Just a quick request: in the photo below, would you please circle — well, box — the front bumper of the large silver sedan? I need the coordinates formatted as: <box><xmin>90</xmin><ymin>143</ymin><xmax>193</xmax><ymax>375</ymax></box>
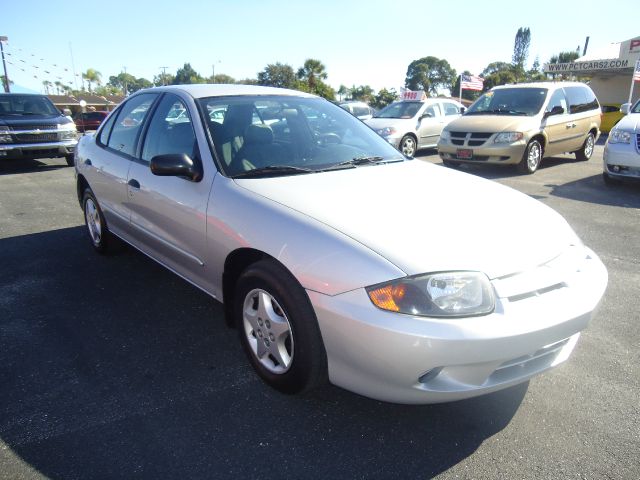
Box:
<box><xmin>308</xmin><ymin>247</ymin><xmax>607</xmax><ymax>404</ymax></box>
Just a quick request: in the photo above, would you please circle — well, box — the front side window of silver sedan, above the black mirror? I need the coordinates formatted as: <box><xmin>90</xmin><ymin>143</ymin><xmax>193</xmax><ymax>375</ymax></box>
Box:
<box><xmin>142</xmin><ymin>94</ymin><xmax>198</xmax><ymax>162</ymax></box>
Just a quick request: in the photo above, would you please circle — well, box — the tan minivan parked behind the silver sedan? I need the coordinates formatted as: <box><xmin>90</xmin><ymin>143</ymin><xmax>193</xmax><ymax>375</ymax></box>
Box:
<box><xmin>438</xmin><ymin>82</ymin><xmax>601</xmax><ymax>173</ymax></box>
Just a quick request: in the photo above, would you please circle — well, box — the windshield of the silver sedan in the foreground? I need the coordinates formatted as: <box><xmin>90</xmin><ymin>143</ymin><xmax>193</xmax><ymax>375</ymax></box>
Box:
<box><xmin>199</xmin><ymin>95</ymin><xmax>404</xmax><ymax>176</ymax></box>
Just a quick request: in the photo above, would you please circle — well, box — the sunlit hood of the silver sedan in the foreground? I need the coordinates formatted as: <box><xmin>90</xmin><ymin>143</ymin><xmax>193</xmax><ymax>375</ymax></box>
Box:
<box><xmin>236</xmin><ymin>160</ymin><xmax>580</xmax><ymax>278</ymax></box>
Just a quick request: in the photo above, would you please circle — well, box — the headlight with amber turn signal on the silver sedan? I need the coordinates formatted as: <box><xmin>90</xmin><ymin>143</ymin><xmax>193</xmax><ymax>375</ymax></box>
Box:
<box><xmin>367</xmin><ymin>272</ymin><xmax>495</xmax><ymax>317</ymax></box>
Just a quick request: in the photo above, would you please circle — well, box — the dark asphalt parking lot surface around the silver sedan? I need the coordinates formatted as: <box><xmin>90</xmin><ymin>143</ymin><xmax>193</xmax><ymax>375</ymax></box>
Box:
<box><xmin>0</xmin><ymin>142</ymin><xmax>640</xmax><ymax>479</ymax></box>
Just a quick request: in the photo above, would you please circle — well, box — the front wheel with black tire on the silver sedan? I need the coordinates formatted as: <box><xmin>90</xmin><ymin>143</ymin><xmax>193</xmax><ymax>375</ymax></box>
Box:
<box><xmin>233</xmin><ymin>259</ymin><xmax>327</xmax><ymax>394</ymax></box>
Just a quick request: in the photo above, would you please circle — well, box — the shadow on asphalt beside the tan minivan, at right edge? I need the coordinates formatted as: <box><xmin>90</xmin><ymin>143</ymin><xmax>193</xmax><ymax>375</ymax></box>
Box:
<box><xmin>545</xmin><ymin>175</ymin><xmax>640</xmax><ymax>208</ymax></box>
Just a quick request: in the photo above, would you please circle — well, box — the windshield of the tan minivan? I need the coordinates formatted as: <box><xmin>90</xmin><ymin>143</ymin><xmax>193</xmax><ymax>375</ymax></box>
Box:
<box><xmin>465</xmin><ymin>88</ymin><xmax>548</xmax><ymax>117</ymax></box>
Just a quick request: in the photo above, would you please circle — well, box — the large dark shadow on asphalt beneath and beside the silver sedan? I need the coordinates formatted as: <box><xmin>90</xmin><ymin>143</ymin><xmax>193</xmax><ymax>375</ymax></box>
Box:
<box><xmin>0</xmin><ymin>227</ymin><xmax>528</xmax><ymax>479</ymax></box>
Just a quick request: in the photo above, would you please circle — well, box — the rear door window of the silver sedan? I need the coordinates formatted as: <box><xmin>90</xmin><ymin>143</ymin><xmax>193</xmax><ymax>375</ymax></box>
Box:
<box><xmin>107</xmin><ymin>93</ymin><xmax>158</xmax><ymax>156</ymax></box>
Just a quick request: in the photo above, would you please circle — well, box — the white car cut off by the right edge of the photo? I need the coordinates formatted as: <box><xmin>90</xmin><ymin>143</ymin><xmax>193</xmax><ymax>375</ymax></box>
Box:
<box><xmin>602</xmin><ymin>101</ymin><xmax>640</xmax><ymax>184</ymax></box>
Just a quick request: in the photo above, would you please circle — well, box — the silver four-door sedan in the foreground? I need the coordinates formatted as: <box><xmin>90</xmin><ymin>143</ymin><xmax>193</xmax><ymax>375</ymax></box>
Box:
<box><xmin>76</xmin><ymin>85</ymin><xmax>607</xmax><ymax>403</ymax></box>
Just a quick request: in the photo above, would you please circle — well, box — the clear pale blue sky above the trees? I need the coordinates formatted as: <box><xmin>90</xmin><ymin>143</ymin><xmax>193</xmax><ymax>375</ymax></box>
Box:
<box><xmin>0</xmin><ymin>0</ymin><xmax>640</xmax><ymax>92</ymax></box>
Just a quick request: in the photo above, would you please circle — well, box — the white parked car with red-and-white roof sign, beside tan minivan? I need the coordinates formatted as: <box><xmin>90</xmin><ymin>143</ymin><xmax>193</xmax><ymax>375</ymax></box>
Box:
<box><xmin>366</xmin><ymin>98</ymin><xmax>464</xmax><ymax>157</ymax></box>
